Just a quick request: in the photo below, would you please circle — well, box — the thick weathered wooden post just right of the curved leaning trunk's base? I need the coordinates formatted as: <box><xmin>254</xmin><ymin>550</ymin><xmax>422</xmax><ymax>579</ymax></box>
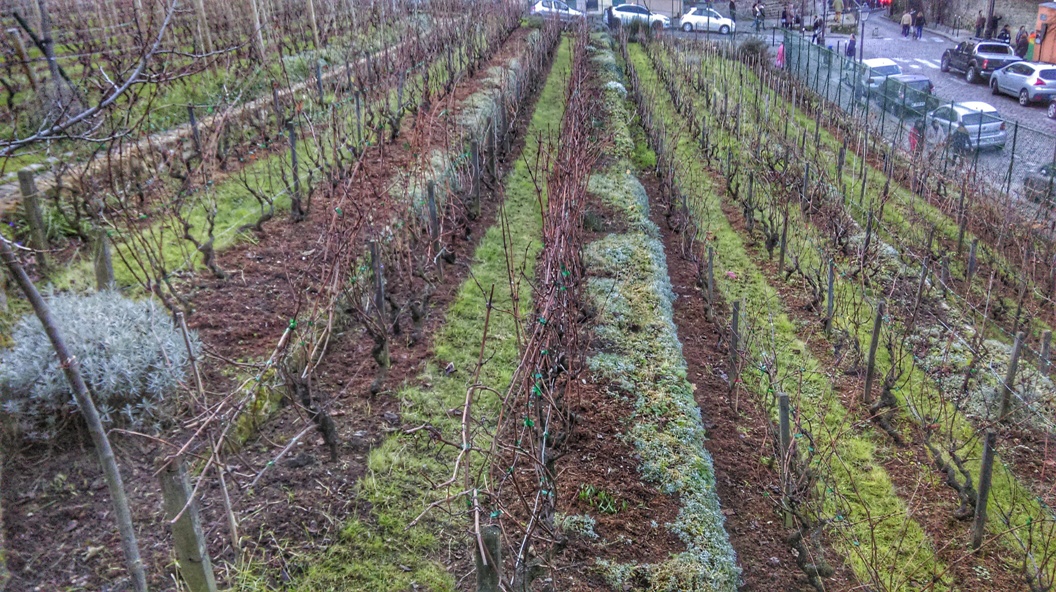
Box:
<box><xmin>158</xmin><ymin>458</ymin><xmax>216</xmax><ymax>592</ymax></box>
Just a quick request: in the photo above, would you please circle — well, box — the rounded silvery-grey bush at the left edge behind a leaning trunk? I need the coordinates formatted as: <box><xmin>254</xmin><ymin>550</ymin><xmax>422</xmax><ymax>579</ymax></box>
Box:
<box><xmin>0</xmin><ymin>291</ymin><xmax>201</xmax><ymax>439</ymax></box>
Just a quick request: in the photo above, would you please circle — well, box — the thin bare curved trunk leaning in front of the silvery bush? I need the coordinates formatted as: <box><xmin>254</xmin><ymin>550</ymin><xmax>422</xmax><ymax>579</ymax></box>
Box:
<box><xmin>0</xmin><ymin>235</ymin><xmax>147</xmax><ymax>592</ymax></box>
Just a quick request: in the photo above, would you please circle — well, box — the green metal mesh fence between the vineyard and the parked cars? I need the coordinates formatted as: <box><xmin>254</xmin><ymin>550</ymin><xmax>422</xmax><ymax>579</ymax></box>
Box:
<box><xmin>782</xmin><ymin>31</ymin><xmax>1056</xmax><ymax>200</ymax></box>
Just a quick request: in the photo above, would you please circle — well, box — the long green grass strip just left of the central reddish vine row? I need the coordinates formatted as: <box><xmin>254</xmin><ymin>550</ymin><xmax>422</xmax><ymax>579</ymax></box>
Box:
<box><xmin>266</xmin><ymin>40</ymin><xmax>571</xmax><ymax>592</ymax></box>
